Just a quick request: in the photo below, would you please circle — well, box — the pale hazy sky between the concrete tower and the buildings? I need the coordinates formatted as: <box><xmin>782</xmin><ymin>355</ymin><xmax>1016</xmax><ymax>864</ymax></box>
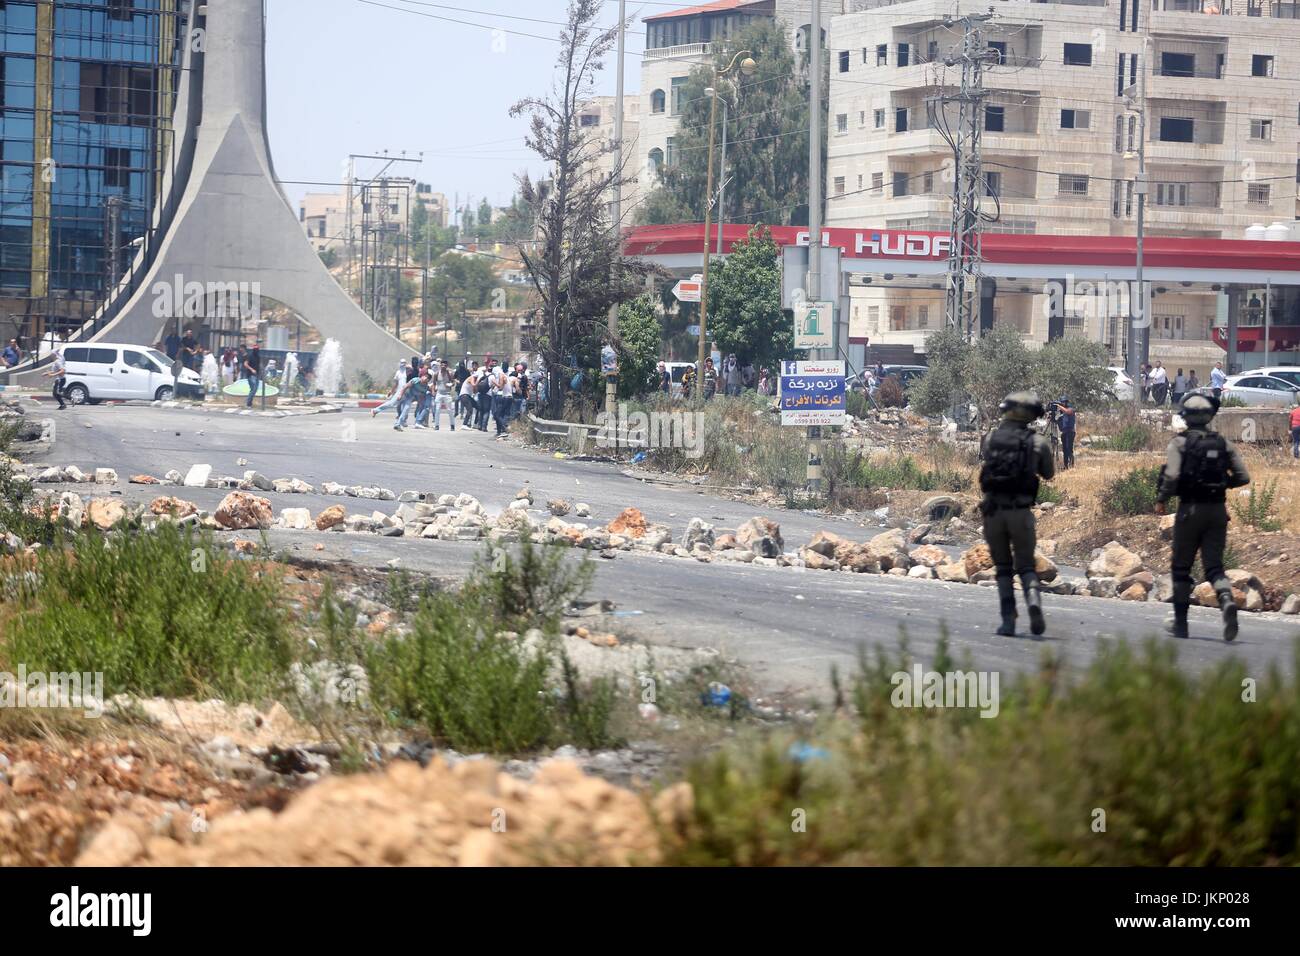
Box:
<box><xmin>267</xmin><ymin>0</ymin><xmax>650</xmax><ymax>214</ymax></box>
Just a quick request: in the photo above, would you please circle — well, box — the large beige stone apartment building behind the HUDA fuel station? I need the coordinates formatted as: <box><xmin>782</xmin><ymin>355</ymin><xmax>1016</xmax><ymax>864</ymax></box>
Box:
<box><xmin>827</xmin><ymin>0</ymin><xmax>1300</xmax><ymax>368</ymax></box>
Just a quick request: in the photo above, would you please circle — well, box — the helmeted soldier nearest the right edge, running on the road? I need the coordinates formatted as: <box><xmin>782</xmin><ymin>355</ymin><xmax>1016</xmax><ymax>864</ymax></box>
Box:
<box><xmin>1156</xmin><ymin>394</ymin><xmax>1251</xmax><ymax>641</ymax></box>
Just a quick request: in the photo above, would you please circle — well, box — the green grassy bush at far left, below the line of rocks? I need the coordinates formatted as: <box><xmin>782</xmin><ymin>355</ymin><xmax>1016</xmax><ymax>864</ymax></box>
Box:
<box><xmin>0</xmin><ymin>524</ymin><xmax>293</xmax><ymax>700</ymax></box>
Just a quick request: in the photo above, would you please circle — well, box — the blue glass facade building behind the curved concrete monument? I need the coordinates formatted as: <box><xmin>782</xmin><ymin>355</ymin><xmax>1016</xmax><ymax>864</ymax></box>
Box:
<box><xmin>0</xmin><ymin>0</ymin><xmax>189</xmax><ymax>349</ymax></box>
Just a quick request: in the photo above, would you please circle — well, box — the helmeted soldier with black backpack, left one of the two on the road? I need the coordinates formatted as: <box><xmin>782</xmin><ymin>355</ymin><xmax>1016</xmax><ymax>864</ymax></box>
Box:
<box><xmin>979</xmin><ymin>392</ymin><xmax>1056</xmax><ymax>637</ymax></box>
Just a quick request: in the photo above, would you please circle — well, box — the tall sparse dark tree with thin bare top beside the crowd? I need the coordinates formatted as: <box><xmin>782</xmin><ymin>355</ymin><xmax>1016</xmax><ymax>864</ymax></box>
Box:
<box><xmin>510</xmin><ymin>0</ymin><xmax>658</xmax><ymax>418</ymax></box>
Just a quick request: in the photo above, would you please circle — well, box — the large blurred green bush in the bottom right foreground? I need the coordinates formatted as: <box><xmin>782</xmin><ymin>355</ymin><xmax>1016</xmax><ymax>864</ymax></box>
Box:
<box><xmin>663</xmin><ymin>641</ymin><xmax>1300</xmax><ymax>866</ymax></box>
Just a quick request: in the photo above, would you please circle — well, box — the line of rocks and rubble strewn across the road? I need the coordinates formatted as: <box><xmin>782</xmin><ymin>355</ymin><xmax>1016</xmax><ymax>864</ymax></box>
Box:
<box><xmin>9</xmin><ymin>466</ymin><xmax>1300</xmax><ymax>614</ymax></box>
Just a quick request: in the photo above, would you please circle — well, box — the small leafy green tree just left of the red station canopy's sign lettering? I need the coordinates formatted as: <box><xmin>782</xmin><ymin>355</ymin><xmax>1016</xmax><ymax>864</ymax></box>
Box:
<box><xmin>706</xmin><ymin>226</ymin><xmax>794</xmax><ymax>367</ymax></box>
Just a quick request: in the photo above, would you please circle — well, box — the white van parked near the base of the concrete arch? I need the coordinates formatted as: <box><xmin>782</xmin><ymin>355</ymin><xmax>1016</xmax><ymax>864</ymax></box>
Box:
<box><xmin>64</xmin><ymin>342</ymin><xmax>203</xmax><ymax>405</ymax></box>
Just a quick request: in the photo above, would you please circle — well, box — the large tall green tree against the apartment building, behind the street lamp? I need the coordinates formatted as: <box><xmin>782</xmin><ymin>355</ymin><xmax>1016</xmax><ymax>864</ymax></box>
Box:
<box><xmin>638</xmin><ymin>20</ymin><xmax>824</xmax><ymax>225</ymax></box>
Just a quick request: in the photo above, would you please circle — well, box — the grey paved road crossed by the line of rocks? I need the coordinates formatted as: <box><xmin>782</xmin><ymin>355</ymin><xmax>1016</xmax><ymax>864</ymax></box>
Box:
<box><xmin>22</xmin><ymin>406</ymin><xmax>1300</xmax><ymax>693</ymax></box>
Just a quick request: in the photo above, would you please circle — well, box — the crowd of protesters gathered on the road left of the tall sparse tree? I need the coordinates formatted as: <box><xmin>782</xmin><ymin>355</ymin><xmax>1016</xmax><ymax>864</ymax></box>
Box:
<box><xmin>371</xmin><ymin>355</ymin><xmax>541</xmax><ymax>438</ymax></box>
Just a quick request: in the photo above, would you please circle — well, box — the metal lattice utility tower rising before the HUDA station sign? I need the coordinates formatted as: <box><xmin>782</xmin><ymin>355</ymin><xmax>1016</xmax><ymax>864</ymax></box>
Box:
<box><xmin>932</xmin><ymin>8</ymin><xmax>998</xmax><ymax>342</ymax></box>
